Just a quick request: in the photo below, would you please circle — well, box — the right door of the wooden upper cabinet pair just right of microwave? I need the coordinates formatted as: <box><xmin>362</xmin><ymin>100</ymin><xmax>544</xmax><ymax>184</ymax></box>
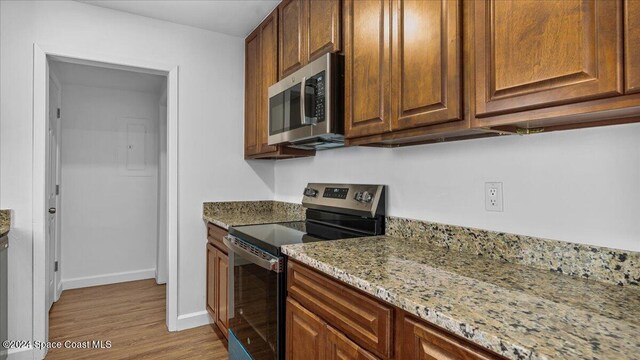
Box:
<box><xmin>391</xmin><ymin>0</ymin><xmax>462</xmax><ymax>130</ymax></box>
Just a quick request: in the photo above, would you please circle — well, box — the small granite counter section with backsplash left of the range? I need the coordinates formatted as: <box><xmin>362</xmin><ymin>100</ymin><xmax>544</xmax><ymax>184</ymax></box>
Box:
<box><xmin>202</xmin><ymin>200</ymin><xmax>305</xmax><ymax>229</ymax></box>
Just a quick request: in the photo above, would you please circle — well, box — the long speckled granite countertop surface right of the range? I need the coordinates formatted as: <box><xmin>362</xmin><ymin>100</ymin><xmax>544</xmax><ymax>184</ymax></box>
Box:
<box><xmin>283</xmin><ymin>236</ymin><xmax>640</xmax><ymax>359</ymax></box>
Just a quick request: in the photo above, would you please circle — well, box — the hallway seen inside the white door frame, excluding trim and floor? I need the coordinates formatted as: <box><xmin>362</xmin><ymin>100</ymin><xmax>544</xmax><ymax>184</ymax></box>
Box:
<box><xmin>45</xmin><ymin>59</ymin><xmax>167</xmax><ymax>336</ymax></box>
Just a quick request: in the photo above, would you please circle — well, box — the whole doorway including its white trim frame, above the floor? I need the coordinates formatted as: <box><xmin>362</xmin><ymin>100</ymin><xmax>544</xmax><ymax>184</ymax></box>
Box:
<box><xmin>33</xmin><ymin>44</ymin><xmax>178</xmax><ymax>357</ymax></box>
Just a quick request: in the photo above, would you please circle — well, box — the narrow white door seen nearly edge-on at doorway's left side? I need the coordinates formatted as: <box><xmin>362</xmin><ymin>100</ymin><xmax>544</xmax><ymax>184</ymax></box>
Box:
<box><xmin>45</xmin><ymin>71</ymin><xmax>60</xmax><ymax>310</ymax></box>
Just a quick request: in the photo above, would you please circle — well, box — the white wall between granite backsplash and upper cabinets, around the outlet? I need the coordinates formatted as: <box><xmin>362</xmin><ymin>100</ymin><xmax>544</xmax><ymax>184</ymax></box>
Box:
<box><xmin>275</xmin><ymin>124</ymin><xmax>640</xmax><ymax>251</ymax></box>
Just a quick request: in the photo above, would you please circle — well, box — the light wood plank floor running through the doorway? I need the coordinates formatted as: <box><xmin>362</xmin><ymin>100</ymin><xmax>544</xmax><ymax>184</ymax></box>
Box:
<box><xmin>46</xmin><ymin>280</ymin><xmax>227</xmax><ymax>360</ymax></box>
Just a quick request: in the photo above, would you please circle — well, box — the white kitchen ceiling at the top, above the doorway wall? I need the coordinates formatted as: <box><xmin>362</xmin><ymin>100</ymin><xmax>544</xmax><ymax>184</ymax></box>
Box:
<box><xmin>76</xmin><ymin>0</ymin><xmax>279</xmax><ymax>37</ymax></box>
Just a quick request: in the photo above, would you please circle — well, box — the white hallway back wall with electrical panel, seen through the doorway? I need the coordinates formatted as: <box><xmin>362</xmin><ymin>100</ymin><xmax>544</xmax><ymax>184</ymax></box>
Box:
<box><xmin>60</xmin><ymin>80</ymin><xmax>160</xmax><ymax>289</ymax></box>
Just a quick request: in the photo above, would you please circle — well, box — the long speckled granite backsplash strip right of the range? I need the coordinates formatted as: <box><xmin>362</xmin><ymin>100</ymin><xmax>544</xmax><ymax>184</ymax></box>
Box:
<box><xmin>385</xmin><ymin>217</ymin><xmax>640</xmax><ymax>286</ymax></box>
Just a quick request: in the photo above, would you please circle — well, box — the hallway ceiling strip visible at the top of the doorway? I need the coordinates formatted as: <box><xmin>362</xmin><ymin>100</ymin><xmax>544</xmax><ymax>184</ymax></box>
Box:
<box><xmin>49</xmin><ymin>61</ymin><xmax>166</xmax><ymax>94</ymax></box>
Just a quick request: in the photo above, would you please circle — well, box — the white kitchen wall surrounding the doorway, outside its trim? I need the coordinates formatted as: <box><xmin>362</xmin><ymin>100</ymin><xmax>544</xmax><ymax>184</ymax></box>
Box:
<box><xmin>0</xmin><ymin>1</ymin><xmax>274</xmax><ymax>348</ymax></box>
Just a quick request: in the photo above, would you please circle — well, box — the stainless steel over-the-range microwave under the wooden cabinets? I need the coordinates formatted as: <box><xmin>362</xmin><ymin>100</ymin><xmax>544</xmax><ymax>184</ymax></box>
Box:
<box><xmin>269</xmin><ymin>54</ymin><xmax>344</xmax><ymax>150</ymax></box>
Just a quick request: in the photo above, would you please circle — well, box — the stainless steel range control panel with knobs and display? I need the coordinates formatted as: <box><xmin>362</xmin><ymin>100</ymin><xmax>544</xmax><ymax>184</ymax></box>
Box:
<box><xmin>302</xmin><ymin>183</ymin><xmax>385</xmax><ymax>217</ymax></box>
